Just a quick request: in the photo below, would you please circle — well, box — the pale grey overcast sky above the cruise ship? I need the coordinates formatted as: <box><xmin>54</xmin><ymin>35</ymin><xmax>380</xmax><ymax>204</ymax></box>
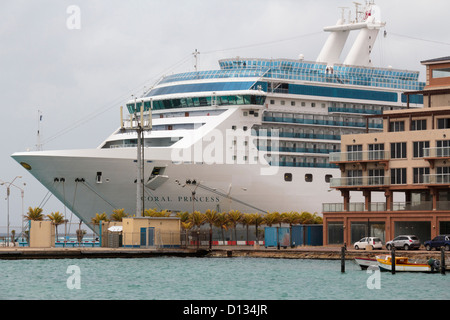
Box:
<box><xmin>0</xmin><ymin>0</ymin><xmax>450</xmax><ymax>232</ymax></box>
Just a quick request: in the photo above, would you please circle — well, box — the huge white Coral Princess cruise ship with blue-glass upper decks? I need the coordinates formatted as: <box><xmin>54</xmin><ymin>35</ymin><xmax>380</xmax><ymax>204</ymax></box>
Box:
<box><xmin>12</xmin><ymin>1</ymin><xmax>424</xmax><ymax>229</ymax></box>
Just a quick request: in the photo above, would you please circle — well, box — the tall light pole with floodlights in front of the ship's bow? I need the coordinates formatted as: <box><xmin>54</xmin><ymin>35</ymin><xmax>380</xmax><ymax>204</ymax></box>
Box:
<box><xmin>120</xmin><ymin>98</ymin><xmax>153</xmax><ymax>217</ymax></box>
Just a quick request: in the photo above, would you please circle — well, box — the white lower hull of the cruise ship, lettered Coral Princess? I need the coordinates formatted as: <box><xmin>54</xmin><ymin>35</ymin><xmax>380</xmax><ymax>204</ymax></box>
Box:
<box><xmin>13</xmin><ymin>148</ymin><xmax>339</xmax><ymax>224</ymax></box>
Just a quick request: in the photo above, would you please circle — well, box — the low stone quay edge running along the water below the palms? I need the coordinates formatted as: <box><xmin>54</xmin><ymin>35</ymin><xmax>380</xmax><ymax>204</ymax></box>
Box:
<box><xmin>0</xmin><ymin>246</ymin><xmax>444</xmax><ymax>265</ymax></box>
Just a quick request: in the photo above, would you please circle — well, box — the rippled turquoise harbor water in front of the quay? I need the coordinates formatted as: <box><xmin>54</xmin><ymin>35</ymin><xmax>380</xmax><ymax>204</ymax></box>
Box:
<box><xmin>0</xmin><ymin>257</ymin><xmax>450</xmax><ymax>300</ymax></box>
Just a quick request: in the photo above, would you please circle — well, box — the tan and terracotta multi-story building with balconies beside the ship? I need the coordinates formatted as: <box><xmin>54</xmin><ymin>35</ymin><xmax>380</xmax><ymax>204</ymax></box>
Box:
<box><xmin>323</xmin><ymin>57</ymin><xmax>450</xmax><ymax>244</ymax></box>
